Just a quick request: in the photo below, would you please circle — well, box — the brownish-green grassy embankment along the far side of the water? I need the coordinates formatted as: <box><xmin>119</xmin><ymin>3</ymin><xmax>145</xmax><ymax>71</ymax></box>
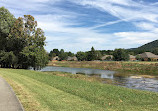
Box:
<box><xmin>48</xmin><ymin>61</ymin><xmax>158</xmax><ymax>75</ymax></box>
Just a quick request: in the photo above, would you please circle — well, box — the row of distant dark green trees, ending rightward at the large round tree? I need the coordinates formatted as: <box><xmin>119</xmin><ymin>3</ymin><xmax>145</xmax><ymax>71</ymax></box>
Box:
<box><xmin>49</xmin><ymin>47</ymin><xmax>129</xmax><ymax>61</ymax></box>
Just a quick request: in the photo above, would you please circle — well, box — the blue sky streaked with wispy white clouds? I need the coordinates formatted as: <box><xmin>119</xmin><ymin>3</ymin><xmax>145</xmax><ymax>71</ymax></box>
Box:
<box><xmin>0</xmin><ymin>0</ymin><xmax>158</xmax><ymax>52</ymax></box>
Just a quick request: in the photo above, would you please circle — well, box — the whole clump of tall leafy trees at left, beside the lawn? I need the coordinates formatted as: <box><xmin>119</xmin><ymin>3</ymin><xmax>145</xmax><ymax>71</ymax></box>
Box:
<box><xmin>0</xmin><ymin>7</ymin><xmax>48</xmax><ymax>69</ymax></box>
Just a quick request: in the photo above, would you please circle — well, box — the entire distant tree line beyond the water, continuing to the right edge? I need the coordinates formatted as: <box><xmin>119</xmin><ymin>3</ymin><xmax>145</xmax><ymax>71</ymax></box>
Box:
<box><xmin>49</xmin><ymin>44</ymin><xmax>158</xmax><ymax>61</ymax></box>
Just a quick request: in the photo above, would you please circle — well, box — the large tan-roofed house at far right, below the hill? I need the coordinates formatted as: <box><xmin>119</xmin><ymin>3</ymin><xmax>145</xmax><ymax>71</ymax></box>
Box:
<box><xmin>139</xmin><ymin>52</ymin><xmax>158</xmax><ymax>61</ymax></box>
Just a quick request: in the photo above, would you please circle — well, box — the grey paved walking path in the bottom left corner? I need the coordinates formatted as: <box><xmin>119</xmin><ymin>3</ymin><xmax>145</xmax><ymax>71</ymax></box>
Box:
<box><xmin>0</xmin><ymin>77</ymin><xmax>24</xmax><ymax>111</ymax></box>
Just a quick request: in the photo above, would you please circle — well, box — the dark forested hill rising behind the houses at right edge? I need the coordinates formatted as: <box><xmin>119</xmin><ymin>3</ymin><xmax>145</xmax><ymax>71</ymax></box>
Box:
<box><xmin>137</xmin><ymin>40</ymin><xmax>158</xmax><ymax>51</ymax></box>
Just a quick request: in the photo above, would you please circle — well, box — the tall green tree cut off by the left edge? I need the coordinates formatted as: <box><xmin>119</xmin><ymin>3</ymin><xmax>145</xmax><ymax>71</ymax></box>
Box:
<box><xmin>0</xmin><ymin>7</ymin><xmax>16</xmax><ymax>67</ymax></box>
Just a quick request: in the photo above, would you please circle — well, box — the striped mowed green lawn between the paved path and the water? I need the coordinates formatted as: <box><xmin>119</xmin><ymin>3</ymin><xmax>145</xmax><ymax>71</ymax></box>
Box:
<box><xmin>0</xmin><ymin>69</ymin><xmax>158</xmax><ymax>111</ymax></box>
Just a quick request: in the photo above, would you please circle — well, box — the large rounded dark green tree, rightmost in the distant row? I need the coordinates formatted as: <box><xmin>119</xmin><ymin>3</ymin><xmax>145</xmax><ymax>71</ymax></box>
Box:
<box><xmin>113</xmin><ymin>49</ymin><xmax>129</xmax><ymax>61</ymax></box>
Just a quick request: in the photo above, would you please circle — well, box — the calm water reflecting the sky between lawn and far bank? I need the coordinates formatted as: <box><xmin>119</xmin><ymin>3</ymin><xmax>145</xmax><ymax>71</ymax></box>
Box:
<box><xmin>41</xmin><ymin>66</ymin><xmax>158</xmax><ymax>92</ymax></box>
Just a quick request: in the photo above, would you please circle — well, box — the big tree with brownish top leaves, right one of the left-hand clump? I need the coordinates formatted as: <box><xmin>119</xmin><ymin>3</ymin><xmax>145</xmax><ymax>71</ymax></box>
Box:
<box><xmin>8</xmin><ymin>15</ymin><xmax>48</xmax><ymax>69</ymax></box>
